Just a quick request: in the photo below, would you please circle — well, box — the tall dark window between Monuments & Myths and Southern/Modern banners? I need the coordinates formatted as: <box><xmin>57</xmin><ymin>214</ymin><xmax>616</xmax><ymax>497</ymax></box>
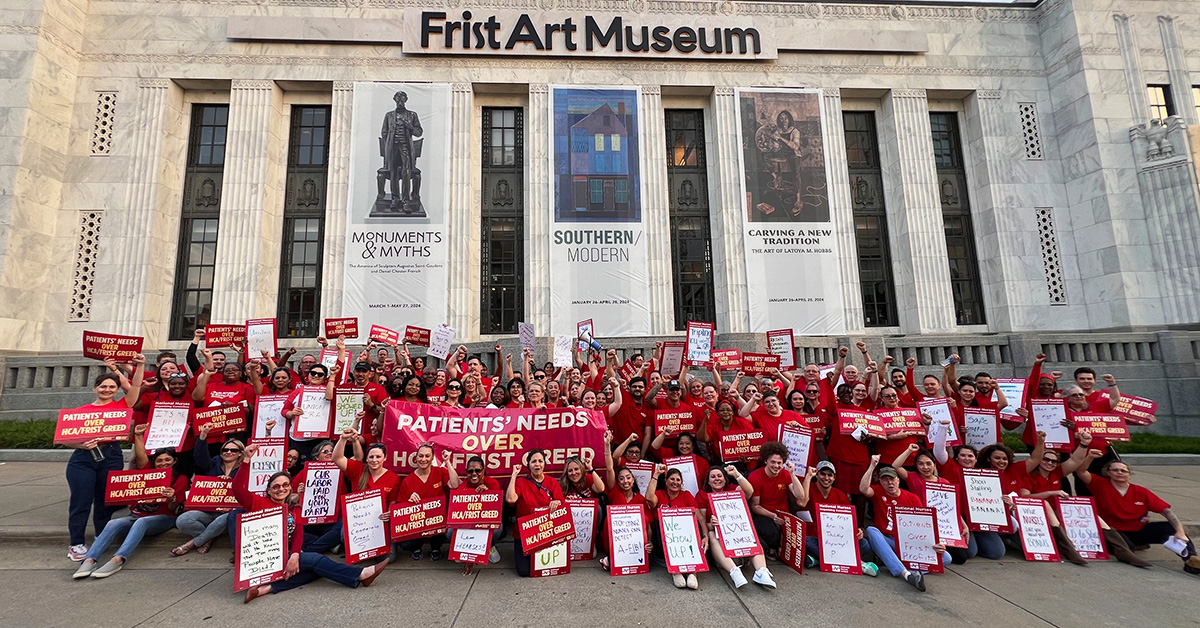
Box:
<box><xmin>479</xmin><ymin>107</ymin><xmax>523</xmax><ymax>334</ymax></box>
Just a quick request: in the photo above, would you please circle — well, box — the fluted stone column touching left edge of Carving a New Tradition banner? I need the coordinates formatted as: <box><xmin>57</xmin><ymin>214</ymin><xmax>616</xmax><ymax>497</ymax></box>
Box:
<box><xmin>706</xmin><ymin>88</ymin><xmax>750</xmax><ymax>334</ymax></box>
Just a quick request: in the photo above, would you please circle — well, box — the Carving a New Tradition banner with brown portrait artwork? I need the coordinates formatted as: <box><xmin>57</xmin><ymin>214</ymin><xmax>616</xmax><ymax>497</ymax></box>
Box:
<box><xmin>737</xmin><ymin>89</ymin><xmax>845</xmax><ymax>336</ymax></box>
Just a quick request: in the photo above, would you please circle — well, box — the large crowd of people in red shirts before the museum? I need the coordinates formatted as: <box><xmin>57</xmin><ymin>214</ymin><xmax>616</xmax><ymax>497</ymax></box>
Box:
<box><xmin>66</xmin><ymin>330</ymin><xmax>1200</xmax><ymax>602</ymax></box>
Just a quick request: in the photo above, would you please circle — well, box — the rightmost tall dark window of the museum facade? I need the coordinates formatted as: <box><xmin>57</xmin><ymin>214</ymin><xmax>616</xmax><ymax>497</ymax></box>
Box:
<box><xmin>929</xmin><ymin>113</ymin><xmax>986</xmax><ymax>325</ymax></box>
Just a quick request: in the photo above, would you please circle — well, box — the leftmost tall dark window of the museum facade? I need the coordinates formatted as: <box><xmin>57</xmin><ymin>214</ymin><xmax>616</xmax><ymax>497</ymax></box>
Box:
<box><xmin>170</xmin><ymin>104</ymin><xmax>229</xmax><ymax>340</ymax></box>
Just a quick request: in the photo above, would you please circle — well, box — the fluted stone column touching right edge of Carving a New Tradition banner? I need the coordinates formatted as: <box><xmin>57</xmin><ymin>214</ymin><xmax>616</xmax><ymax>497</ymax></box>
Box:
<box><xmin>824</xmin><ymin>88</ymin><xmax>863</xmax><ymax>334</ymax></box>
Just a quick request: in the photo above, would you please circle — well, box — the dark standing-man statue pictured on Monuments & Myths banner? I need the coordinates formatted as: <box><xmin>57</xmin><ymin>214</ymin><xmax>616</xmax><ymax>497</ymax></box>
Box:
<box><xmin>371</xmin><ymin>91</ymin><xmax>426</xmax><ymax>217</ymax></box>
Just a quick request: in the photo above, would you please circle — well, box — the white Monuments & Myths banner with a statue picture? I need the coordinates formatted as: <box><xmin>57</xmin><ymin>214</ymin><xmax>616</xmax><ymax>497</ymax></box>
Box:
<box><xmin>345</xmin><ymin>83</ymin><xmax>450</xmax><ymax>329</ymax></box>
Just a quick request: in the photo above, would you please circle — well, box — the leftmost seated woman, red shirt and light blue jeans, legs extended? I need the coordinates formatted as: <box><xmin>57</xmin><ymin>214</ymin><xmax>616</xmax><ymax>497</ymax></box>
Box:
<box><xmin>72</xmin><ymin>446</ymin><xmax>188</xmax><ymax>580</ymax></box>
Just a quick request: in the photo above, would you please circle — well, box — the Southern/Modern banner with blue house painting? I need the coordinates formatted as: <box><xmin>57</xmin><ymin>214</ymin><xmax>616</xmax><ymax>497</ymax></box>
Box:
<box><xmin>548</xmin><ymin>85</ymin><xmax>650</xmax><ymax>336</ymax></box>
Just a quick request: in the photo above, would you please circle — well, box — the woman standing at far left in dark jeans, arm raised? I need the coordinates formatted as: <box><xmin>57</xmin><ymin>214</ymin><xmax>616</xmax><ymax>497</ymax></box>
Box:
<box><xmin>66</xmin><ymin>353</ymin><xmax>146</xmax><ymax>562</ymax></box>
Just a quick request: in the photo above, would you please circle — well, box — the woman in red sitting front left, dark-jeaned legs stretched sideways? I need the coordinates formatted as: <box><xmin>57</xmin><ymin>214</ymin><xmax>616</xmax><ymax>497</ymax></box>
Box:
<box><xmin>233</xmin><ymin>441</ymin><xmax>388</xmax><ymax>604</ymax></box>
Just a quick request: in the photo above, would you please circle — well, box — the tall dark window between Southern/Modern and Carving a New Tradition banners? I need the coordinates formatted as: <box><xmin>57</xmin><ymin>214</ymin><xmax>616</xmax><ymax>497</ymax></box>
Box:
<box><xmin>667</xmin><ymin>109</ymin><xmax>716</xmax><ymax>331</ymax></box>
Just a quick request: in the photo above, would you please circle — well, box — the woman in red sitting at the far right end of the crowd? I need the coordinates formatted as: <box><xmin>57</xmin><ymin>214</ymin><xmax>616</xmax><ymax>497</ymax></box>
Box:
<box><xmin>1075</xmin><ymin>432</ymin><xmax>1200</xmax><ymax>575</ymax></box>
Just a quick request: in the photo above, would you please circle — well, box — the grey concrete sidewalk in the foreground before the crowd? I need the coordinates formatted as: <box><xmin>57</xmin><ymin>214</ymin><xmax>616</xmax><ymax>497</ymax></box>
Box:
<box><xmin>0</xmin><ymin>462</ymin><xmax>1200</xmax><ymax>628</ymax></box>
